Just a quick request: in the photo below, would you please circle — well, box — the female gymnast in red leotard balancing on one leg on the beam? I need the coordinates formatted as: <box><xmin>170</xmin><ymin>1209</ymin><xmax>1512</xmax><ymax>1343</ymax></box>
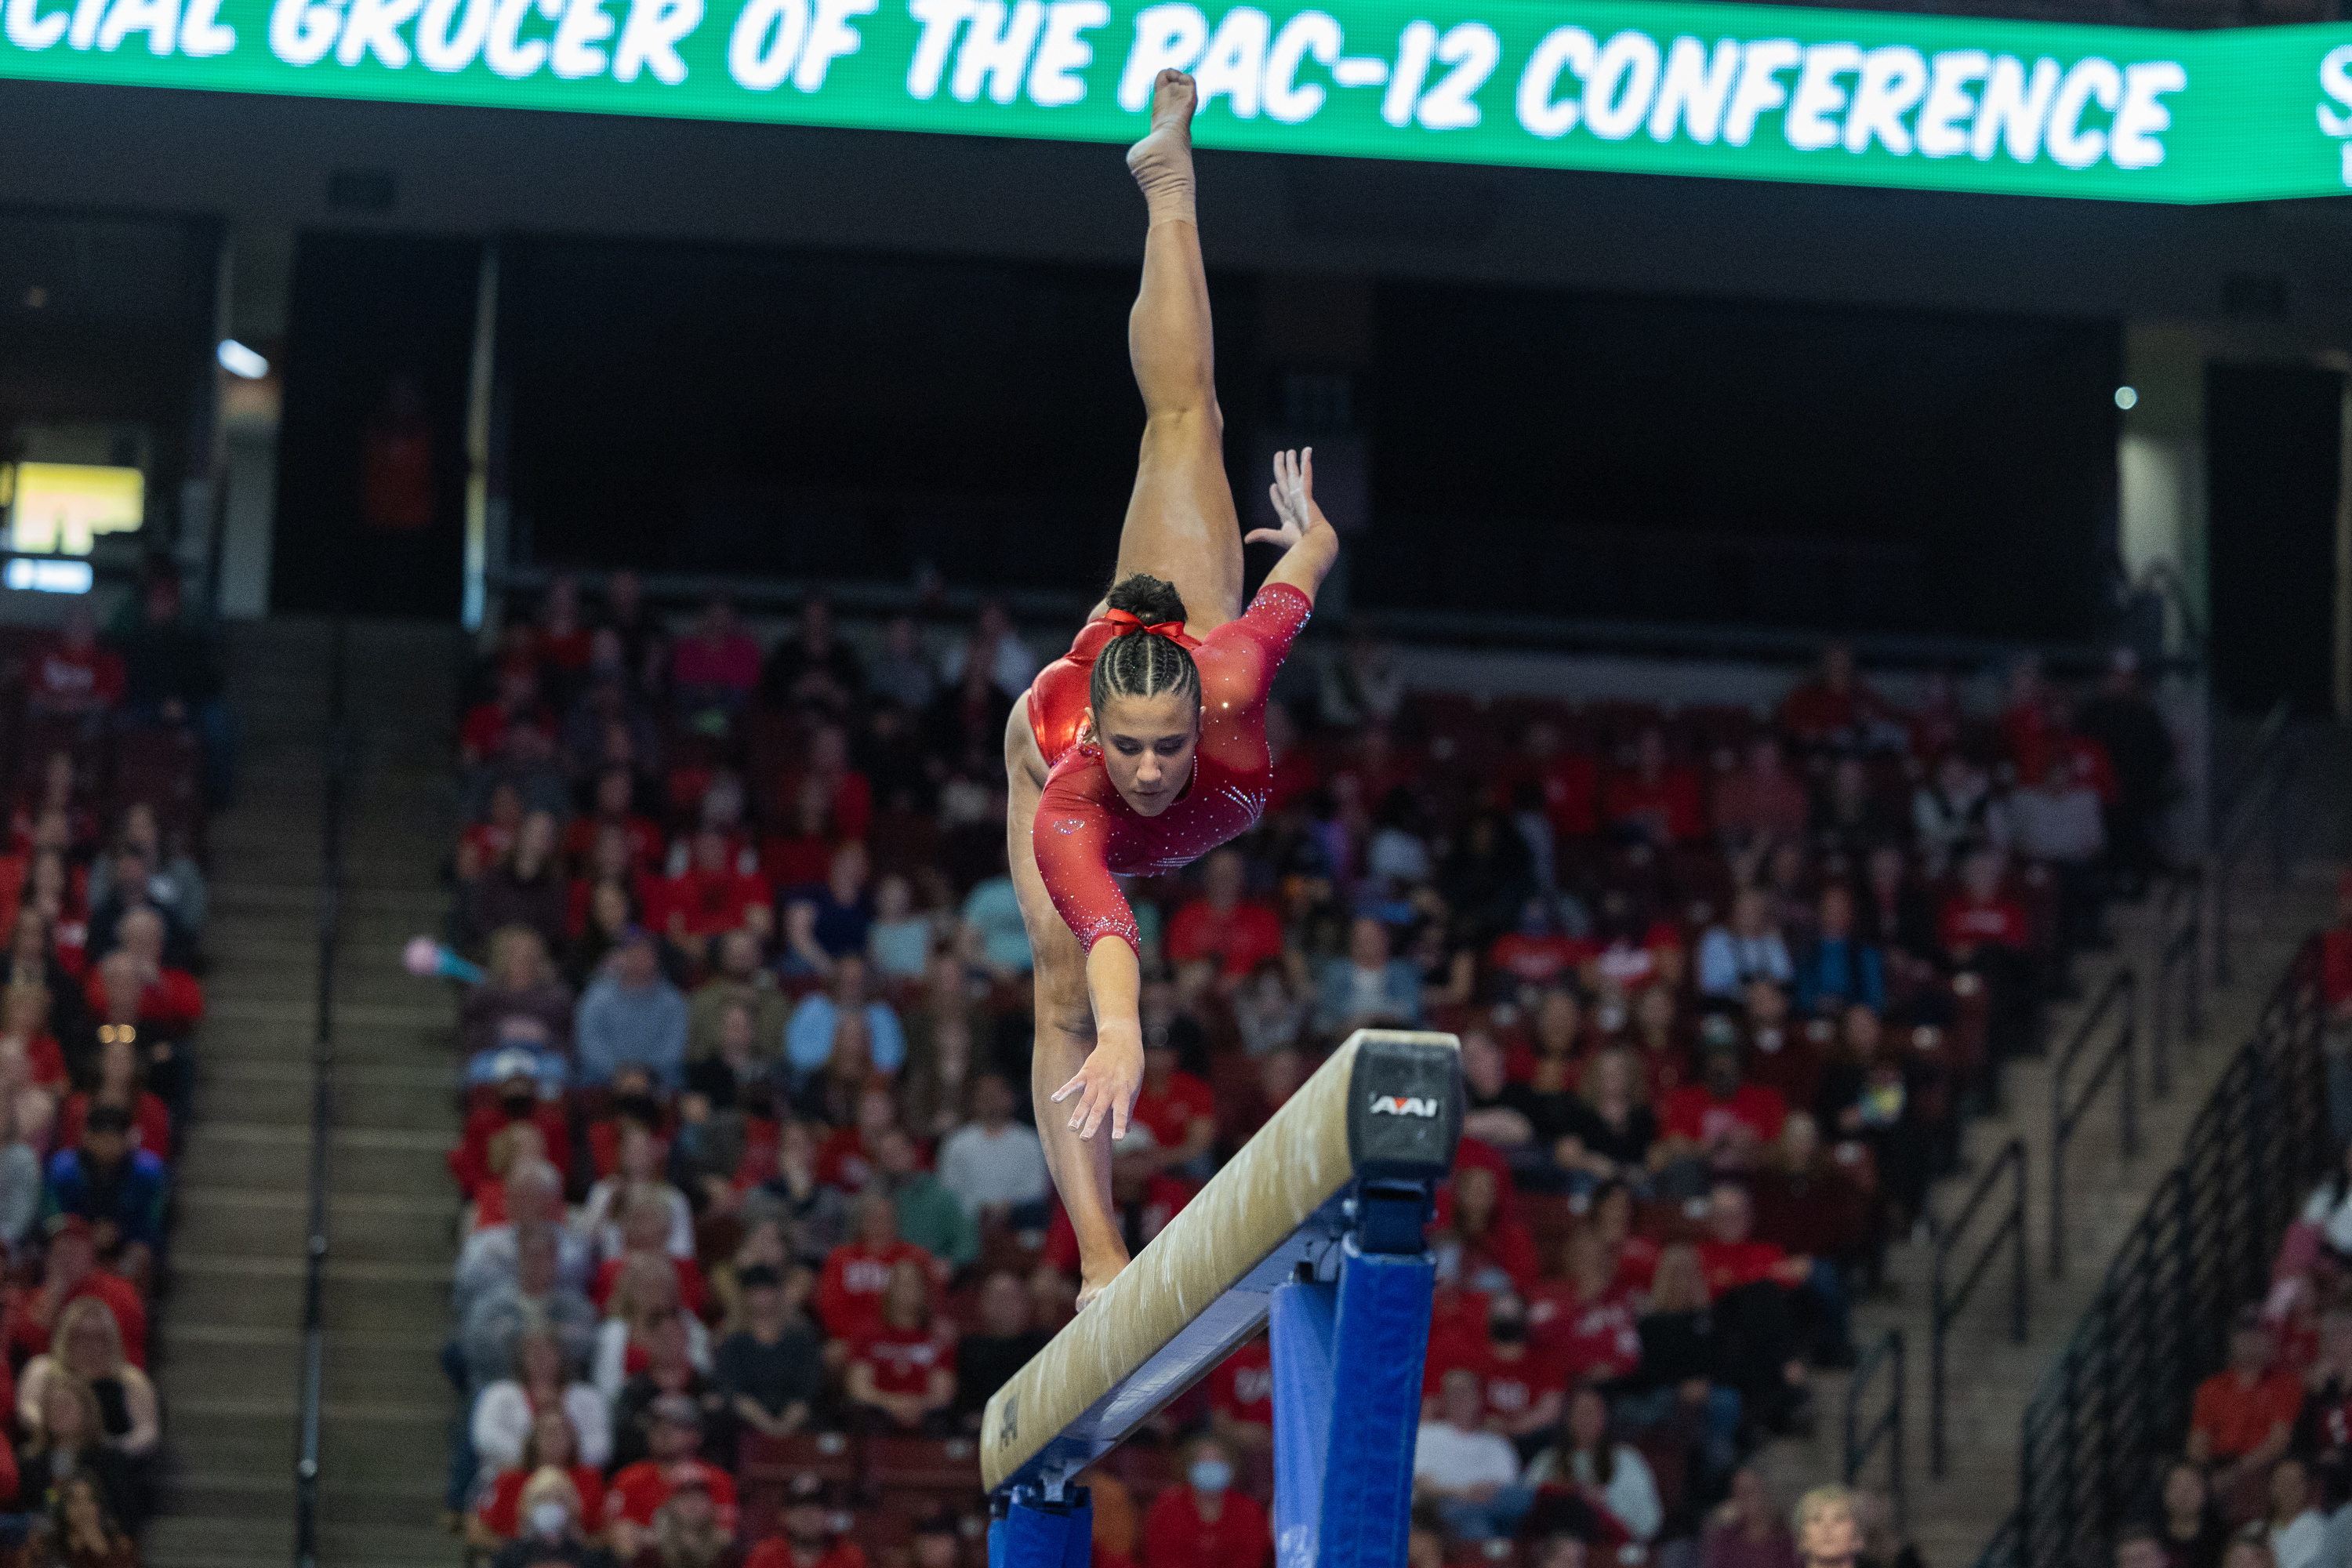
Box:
<box><xmin>1004</xmin><ymin>71</ymin><xmax>1338</xmax><ymax>1305</ymax></box>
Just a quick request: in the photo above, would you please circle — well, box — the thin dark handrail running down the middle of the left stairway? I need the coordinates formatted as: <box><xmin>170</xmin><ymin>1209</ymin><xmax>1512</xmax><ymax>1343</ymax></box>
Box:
<box><xmin>294</xmin><ymin>614</ymin><xmax>350</xmax><ymax>1568</ymax></box>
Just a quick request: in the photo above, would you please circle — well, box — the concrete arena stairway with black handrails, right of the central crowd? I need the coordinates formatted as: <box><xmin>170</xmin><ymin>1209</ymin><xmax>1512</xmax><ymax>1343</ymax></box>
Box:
<box><xmin>1759</xmin><ymin>860</ymin><xmax>2343</xmax><ymax>1568</ymax></box>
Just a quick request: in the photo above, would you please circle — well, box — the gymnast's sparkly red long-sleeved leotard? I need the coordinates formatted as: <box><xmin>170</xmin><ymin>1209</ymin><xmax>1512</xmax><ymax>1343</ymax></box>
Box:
<box><xmin>1028</xmin><ymin>583</ymin><xmax>1312</xmax><ymax>952</ymax></box>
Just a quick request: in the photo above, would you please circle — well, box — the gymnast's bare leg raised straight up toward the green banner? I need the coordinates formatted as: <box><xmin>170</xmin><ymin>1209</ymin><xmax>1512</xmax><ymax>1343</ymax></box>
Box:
<box><xmin>1117</xmin><ymin>71</ymin><xmax>1242</xmax><ymax>637</ymax></box>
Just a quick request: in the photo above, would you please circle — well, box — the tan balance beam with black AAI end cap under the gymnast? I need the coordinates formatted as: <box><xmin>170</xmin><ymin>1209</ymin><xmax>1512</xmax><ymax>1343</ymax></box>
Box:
<box><xmin>981</xmin><ymin>1029</ymin><xmax>1463</xmax><ymax>1504</ymax></box>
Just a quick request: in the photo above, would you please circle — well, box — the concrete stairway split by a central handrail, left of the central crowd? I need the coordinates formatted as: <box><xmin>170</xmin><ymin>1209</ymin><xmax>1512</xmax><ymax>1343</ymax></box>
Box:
<box><xmin>148</xmin><ymin>621</ymin><xmax>463</xmax><ymax>1568</ymax></box>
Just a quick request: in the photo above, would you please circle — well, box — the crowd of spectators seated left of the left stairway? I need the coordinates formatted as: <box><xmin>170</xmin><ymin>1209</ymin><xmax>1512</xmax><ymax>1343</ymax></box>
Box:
<box><xmin>0</xmin><ymin>562</ymin><xmax>233</xmax><ymax>1568</ymax></box>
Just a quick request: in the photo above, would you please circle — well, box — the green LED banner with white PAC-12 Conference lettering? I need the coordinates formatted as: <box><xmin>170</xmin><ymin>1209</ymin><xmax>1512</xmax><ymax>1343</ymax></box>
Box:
<box><xmin>13</xmin><ymin>0</ymin><xmax>2352</xmax><ymax>202</ymax></box>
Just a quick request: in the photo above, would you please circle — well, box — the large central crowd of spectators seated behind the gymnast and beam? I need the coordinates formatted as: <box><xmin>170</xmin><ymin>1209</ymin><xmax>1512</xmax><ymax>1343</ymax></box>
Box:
<box><xmin>445</xmin><ymin>574</ymin><xmax>2171</xmax><ymax>1568</ymax></box>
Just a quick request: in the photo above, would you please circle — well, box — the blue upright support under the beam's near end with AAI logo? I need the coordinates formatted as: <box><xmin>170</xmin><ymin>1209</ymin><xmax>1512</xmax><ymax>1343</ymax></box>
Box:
<box><xmin>1279</xmin><ymin>1236</ymin><xmax>1437</xmax><ymax>1568</ymax></box>
